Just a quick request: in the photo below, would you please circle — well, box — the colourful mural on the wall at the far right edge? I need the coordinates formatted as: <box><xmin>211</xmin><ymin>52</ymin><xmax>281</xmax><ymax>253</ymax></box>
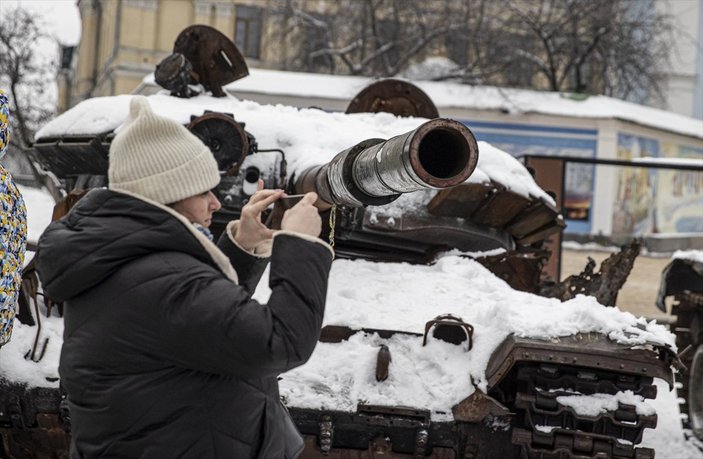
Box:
<box><xmin>612</xmin><ymin>133</ymin><xmax>703</xmax><ymax>235</ymax></box>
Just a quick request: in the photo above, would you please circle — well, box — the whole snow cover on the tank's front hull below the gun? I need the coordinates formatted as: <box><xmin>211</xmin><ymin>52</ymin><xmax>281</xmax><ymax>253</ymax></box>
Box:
<box><xmin>255</xmin><ymin>254</ymin><xmax>676</xmax><ymax>419</ymax></box>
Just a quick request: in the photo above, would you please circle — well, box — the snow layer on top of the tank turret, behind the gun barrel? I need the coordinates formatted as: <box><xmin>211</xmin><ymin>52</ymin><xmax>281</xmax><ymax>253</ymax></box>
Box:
<box><xmin>36</xmin><ymin>94</ymin><xmax>554</xmax><ymax>204</ymax></box>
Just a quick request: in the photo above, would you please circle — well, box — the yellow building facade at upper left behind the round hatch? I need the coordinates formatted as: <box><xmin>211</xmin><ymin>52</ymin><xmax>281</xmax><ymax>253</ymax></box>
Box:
<box><xmin>59</xmin><ymin>0</ymin><xmax>278</xmax><ymax>112</ymax></box>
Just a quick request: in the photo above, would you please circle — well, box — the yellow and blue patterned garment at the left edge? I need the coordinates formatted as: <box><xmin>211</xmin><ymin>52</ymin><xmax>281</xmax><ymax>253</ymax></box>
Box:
<box><xmin>0</xmin><ymin>90</ymin><xmax>27</xmax><ymax>346</ymax></box>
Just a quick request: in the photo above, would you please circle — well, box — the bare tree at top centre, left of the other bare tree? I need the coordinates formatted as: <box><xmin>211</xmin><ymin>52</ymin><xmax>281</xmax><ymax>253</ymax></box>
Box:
<box><xmin>275</xmin><ymin>0</ymin><xmax>483</xmax><ymax>77</ymax></box>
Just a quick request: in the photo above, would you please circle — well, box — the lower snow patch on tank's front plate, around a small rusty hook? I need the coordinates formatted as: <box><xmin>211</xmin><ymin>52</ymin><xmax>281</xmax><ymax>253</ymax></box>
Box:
<box><xmin>279</xmin><ymin>333</ymin><xmax>476</xmax><ymax>421</ymax></box>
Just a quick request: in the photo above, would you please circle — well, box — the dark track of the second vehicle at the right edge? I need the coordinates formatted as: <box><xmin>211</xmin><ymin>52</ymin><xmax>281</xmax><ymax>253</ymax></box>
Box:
<box><xmin>671</xmin><ymin>292</ymin><xmax>703</xmax><ymax>437</ymax></box>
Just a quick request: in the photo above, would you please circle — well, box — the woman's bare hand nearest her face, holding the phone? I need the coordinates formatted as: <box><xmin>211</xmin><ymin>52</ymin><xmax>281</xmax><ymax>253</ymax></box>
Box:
<box><xmin>234</xmin><ymin>180</ymin><xmax>284</xmax><ymax>251</ymax></box>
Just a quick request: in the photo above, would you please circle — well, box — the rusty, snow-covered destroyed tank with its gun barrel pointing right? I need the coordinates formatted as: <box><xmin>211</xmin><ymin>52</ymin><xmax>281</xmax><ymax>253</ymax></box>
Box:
<box><xmin>0</xmin><ymin>26</ymin><xmax>676</xmax><ymax>459</ymax></box>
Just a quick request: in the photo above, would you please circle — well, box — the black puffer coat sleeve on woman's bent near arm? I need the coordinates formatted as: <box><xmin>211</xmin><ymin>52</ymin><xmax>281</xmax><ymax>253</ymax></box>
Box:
<box><xmin>155</xmin><ymin>235</ymin><xmax>332</xmax><ymax>378</ymax></box>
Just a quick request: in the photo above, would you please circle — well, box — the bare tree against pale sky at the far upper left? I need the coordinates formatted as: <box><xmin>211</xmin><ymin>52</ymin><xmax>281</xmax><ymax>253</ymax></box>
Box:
<box><xmin>0</xmin><ymin>8</ymin><xmax>56</xmax><ymax>150</ymax></box>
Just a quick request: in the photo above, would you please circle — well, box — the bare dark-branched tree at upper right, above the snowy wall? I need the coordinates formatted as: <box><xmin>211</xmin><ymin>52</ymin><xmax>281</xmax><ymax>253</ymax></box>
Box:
<box><xmin>498</xmin><ymin>0</ymin><xmax>670</xmax><ymax>98</ymax></box>
